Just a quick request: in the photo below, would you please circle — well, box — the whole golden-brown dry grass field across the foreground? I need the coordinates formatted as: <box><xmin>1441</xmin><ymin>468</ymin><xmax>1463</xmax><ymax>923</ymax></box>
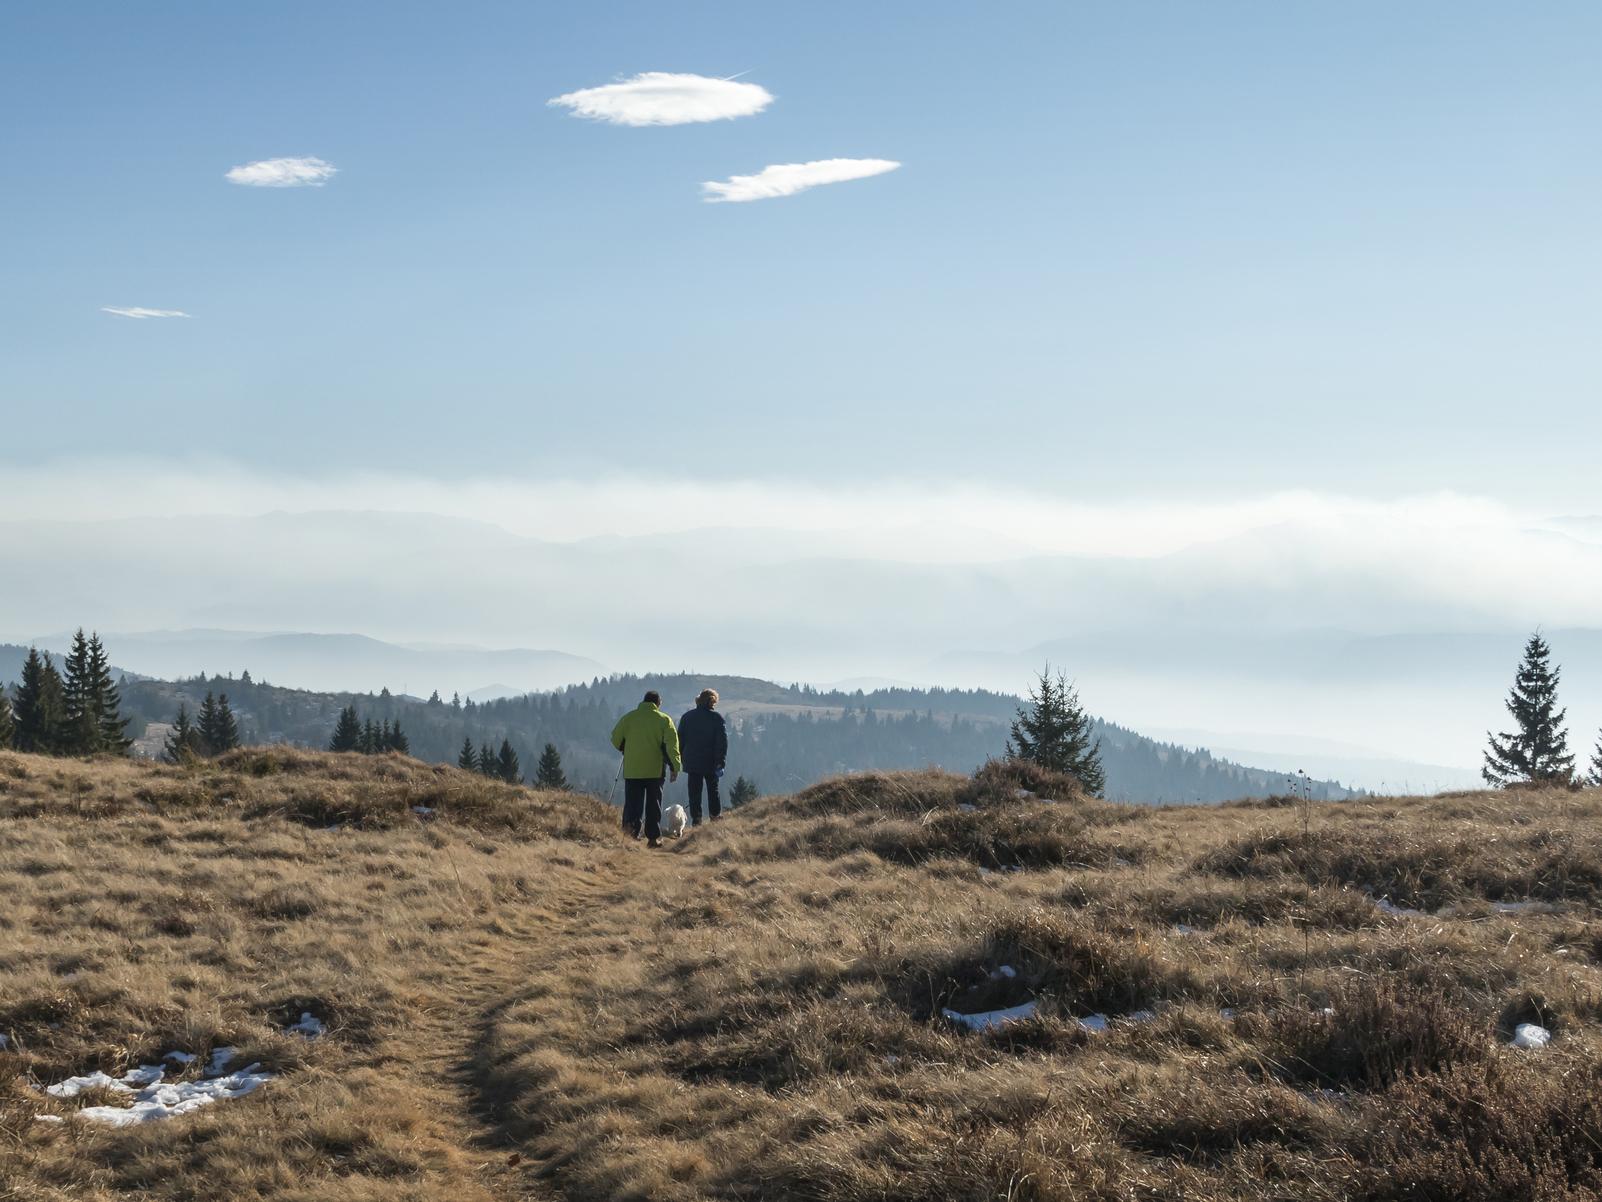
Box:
<box><xmin>0</xmin><ymin>750</ymin><xmax>1602</xmax><ymax>1202</ymax></box>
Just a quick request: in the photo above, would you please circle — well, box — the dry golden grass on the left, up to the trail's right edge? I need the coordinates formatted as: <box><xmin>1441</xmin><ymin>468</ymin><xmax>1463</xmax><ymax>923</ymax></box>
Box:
<box><xmin>0</xmin><ymin>752</ymin><xmax>612</xmax><ymax>1202</ymax></box>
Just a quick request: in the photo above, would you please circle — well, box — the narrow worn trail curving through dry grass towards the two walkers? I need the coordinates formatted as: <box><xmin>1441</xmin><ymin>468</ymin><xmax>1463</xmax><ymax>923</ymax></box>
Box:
<box><xmin>381</xmin><ymin>848</ymin><xmax>642</xmax><ymax>1202</ymax></box>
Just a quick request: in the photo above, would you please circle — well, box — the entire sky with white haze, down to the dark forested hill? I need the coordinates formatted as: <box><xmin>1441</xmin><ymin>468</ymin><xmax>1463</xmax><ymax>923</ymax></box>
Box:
<box><xmin>0</xmin><ymin>0</ymin><xmax>1602</xmax><ymax>785</ymax></box>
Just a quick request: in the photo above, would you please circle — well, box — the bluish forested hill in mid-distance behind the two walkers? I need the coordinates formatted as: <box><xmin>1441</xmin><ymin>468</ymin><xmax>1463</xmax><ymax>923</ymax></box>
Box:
<box><xmin>0</xmin><ymin>646</ymin><xmax>1350</xmax><ymax>803</ymax></box>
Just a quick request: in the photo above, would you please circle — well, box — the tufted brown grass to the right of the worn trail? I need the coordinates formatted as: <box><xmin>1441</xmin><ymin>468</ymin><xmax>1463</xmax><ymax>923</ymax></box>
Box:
<box><xmin>487</xmin><ymin>774</ymin><xmax>1602</xmax><ymax>1202</ymax></box>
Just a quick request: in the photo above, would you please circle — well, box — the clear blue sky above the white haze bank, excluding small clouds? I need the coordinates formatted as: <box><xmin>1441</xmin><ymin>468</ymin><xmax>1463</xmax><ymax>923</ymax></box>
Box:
<box><xmin>0</xmin><ymin>0</ymin><xmax>1602</xmax><ymax>500</ymax></box>
